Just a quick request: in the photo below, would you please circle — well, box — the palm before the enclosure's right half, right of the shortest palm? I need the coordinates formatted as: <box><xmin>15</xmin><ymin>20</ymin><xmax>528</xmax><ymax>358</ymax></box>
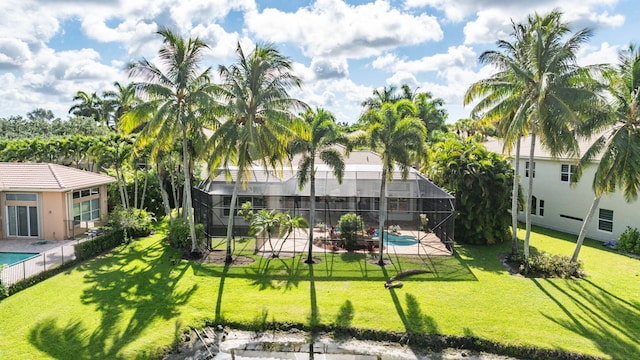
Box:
<box><xmin>359</xmin><ymin>99</ymin><xmax>427</xmax><ymax>265</ymax></box>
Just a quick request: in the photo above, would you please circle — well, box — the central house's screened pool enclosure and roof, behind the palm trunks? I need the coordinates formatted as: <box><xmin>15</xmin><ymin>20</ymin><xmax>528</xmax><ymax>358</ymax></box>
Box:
<box><xmin>193</xmin><ymin>151</ymin><xmax>455</xmax><ymax>254</ymax></box>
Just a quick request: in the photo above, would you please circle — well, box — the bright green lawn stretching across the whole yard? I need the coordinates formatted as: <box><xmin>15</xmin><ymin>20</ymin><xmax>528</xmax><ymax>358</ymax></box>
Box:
<box><xmin>0</xmin><ymin>225</ymin><xmax>640</xmax><ymax>359</ymax></box>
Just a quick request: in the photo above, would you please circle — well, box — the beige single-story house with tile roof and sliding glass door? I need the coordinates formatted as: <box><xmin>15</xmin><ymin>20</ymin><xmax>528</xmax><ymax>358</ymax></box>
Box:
<box><xmin>0</xmin><ymin>162</ymin><xmax>116</xmax><ymax>240</ymax></box>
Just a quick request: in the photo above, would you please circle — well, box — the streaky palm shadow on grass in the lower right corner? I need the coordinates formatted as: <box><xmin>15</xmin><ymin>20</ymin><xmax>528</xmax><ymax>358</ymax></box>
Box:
<box><xmin>532</xmin><ymin>279</ymin><xmax>640</xmax><ymax>359</ymax></box>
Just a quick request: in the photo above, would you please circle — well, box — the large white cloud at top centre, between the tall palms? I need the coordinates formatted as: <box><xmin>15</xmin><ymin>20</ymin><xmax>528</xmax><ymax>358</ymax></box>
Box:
<box><xmin>242</xmin><ymin>0</ymin><xmax>443</xmax><ymax>59</ymax></box>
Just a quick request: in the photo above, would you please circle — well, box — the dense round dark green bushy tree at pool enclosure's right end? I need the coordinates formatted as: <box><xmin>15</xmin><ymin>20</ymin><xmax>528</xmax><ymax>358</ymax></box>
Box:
<box><xmin>428</xmin><ymin>138</ymin><xmax>513</xmax><ymax>245</ymax></box>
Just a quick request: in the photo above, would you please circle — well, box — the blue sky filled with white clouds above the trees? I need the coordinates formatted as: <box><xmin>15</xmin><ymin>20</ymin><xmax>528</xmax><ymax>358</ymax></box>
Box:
<box><xmin>0</xmin><ymin>0</ymin><xmax>640</xmax><ymax>123</ymax></box>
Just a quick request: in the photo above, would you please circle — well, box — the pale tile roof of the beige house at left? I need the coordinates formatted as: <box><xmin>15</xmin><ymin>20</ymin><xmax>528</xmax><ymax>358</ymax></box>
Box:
<box><xmin>0</xmin><ymin>162</ymin><xmax>116</xmax><ymax>191</ymax></box>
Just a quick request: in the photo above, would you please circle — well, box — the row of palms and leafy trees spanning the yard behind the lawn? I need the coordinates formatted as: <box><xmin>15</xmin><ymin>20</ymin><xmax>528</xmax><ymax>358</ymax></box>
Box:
<box><xmin>2</xmin><ymin>11</ymin><xmax>640</xmax><ymax>270</ymax></box>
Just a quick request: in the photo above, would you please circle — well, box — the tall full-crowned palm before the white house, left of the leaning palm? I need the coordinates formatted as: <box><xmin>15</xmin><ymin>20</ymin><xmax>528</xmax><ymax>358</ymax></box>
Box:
<box><xmin>465</xmin><ymin>10</ymin><xmax>600</xmax><ymax>264</ymax></box>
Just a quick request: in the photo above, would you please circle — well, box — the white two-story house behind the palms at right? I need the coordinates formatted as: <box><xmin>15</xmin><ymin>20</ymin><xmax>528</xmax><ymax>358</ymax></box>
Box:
<box><xmin>485</xmin><ymin>136</ymin><xmax>640</xmax><ymax>241</ymax></box>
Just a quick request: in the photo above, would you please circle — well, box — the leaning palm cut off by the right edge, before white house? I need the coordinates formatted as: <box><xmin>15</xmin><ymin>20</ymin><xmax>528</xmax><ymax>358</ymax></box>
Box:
<box><xmin>571</xmin><ymin>44</ymin><xmax>640</xmax><ymax>262</ymax></box>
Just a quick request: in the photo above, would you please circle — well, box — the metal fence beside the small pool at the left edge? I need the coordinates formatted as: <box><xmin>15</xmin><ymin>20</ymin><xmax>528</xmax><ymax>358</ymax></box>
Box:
<box><xmin>0</xmin><ymin>240</ymin><xmax>80</xmax><ymax>286</ymax></box>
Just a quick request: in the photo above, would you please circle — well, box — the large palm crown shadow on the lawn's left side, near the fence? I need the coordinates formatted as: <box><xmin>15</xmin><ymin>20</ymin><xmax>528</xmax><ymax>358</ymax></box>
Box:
<box><xmin>29</xmin><ymin>241</ymin><xmax>197</xmax><ymax>359</ymax></box>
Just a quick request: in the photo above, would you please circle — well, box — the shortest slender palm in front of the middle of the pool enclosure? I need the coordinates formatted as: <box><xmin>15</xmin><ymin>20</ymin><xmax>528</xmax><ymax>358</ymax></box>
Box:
<box><xmin>290</xmin><ymin>109</ymin><xmax>347</xmax><ymax>264</ymax></box>
